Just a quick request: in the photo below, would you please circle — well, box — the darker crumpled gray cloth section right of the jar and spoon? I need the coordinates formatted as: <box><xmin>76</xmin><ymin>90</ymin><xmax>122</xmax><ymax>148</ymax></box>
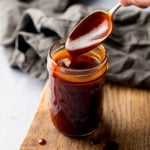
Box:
<box><xmin>104</xmin><ymin>10</ymin><xmax>150</xmax><ymax>88</ymax></box>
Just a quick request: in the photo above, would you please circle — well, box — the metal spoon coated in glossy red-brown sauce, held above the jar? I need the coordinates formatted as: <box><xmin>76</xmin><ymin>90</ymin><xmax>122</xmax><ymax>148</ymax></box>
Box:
<box><xmin>65</xmin><ymin>3</ymin><xmax>121</xmax><ymax>55</ymax></box>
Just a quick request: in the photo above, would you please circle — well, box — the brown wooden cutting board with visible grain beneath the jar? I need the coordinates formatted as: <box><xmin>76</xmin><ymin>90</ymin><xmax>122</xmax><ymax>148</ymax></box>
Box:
<box><xmin>20</xmin><ymin>82</ymin><xmax>150</xmax><ymax>150</ymax></box>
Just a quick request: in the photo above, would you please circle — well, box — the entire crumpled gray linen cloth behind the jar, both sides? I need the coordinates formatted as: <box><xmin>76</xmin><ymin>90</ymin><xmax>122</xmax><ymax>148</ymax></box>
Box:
<box><xmin>0</xmin><ymin>0</ymin><xmax>150</xmax><ymax>88</ymax></box>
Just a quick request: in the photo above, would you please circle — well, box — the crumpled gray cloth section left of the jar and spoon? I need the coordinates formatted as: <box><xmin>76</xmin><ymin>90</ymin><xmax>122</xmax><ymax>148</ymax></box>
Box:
<box><xmin>0</xmin><ymin>0</ymin><xmax>94</xmax><ymax>79</ymax></box>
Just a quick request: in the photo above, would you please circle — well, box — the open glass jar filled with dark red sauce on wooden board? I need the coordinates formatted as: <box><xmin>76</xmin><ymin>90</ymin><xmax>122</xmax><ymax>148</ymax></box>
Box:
<box><xmin>47</xmin><ymin>39</ymin><xmax>108</xmax><ymax>137</ymax></box>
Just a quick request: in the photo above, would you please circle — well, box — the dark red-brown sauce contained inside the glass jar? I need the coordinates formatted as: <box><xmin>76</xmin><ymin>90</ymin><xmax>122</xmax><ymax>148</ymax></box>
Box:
<box><xmin>50</xmin><ymin>52</ymin><xmax>104</xmax><ymax>136</ymax></box>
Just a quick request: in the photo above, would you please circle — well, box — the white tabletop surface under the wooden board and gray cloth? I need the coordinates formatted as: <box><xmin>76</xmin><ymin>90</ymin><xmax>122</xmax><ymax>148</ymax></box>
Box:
<box><xmin>0</xmin><ymin>0</ymin><xmax>148</xmax><ymax>150</ymax></box>
